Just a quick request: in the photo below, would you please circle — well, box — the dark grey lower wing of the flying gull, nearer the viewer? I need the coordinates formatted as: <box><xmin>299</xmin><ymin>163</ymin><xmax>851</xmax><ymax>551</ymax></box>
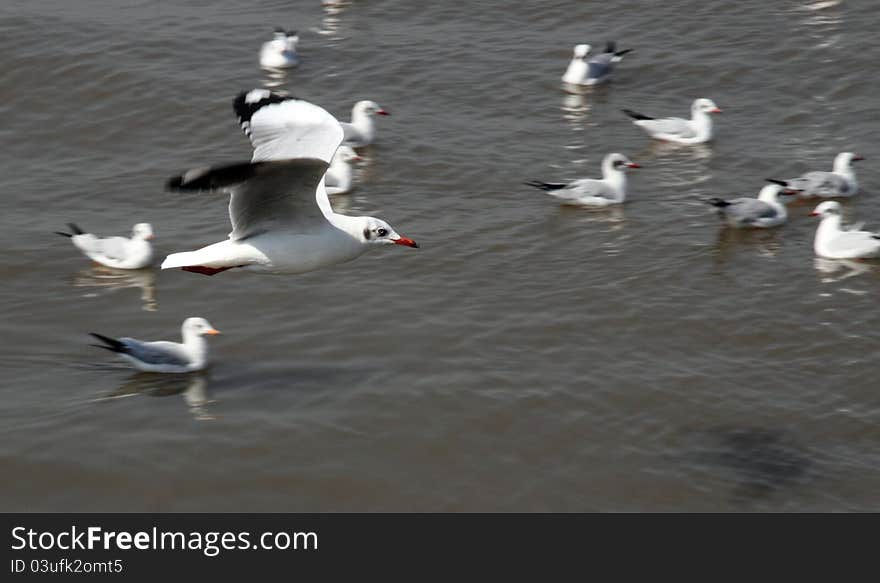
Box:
<box><xmin>168</xmin><ymin>158</ymin><xmax>330</xmax><ymax>240</ymax></box>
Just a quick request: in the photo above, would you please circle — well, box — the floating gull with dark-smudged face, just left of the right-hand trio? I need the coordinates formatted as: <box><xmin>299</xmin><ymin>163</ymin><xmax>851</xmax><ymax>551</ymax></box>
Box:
<box><xmin>526</xmin><ymin>154</ymin><xmax>641</xmax><ymax>206</ymax></box>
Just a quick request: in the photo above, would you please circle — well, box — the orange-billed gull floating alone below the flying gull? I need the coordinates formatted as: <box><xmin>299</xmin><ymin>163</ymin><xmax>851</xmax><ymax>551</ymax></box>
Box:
<box><xmin>89</xmin><ymin>318</ymin><xmax>220</xmax><ymax>373</ymax></box>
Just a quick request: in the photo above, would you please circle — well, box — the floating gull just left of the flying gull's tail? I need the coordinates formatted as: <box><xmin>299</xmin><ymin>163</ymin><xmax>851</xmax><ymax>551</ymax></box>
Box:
<box><xmin>55</xmin><ymin>223</ymin><xmax>153</xmax><ymax>269</ymax></box>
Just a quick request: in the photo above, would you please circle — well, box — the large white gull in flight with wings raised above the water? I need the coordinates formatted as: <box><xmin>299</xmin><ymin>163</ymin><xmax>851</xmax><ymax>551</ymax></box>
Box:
<box><xmin>162</xmin><ymin>89</ymin><xmax>418</xmax><ymax>275</ymax></box>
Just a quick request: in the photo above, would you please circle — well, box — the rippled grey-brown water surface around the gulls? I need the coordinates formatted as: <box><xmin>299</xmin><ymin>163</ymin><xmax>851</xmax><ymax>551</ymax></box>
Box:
<box><xmin>0</xmin><ymin>0</ymin><xmax>880</xmax><ymax>511</ymax></box>
